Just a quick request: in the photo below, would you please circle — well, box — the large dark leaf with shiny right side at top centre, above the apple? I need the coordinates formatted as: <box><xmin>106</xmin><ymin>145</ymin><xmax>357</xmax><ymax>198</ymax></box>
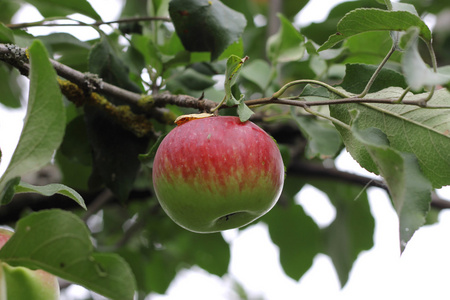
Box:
<box><xmin>169</xmin><ymin>0</ymin><xmax>247</xmax><ymax>60</ymax></box>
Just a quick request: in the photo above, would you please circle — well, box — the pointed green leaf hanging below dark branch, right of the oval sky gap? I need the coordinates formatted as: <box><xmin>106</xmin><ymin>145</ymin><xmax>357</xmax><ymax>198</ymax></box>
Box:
<box><xmin>311</xmin><ymin>181</ymin><xmax>375</xmax><ymax>286</ymax></box>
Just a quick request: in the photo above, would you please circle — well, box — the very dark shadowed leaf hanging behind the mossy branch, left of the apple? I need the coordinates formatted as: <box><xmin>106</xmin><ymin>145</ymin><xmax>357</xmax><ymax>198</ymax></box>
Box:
<box><xmin>85</xmin><ymin>38</ymin><xmax>149</xmax><ymax>201</ymax></box>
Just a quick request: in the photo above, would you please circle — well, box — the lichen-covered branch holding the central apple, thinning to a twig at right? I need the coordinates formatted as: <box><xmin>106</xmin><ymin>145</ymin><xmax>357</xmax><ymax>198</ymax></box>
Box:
<box><xmin>0</xmin><ymin>44</ymin><xmax>450</xmax><ymax>129</ymax></box>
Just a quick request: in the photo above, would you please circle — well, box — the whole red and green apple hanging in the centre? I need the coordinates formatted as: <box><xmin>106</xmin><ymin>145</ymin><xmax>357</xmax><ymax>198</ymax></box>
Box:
<box><xmin>152</xmin><ymin>116</ymin><xmax>285</xmax><ymax>233</ymax></box>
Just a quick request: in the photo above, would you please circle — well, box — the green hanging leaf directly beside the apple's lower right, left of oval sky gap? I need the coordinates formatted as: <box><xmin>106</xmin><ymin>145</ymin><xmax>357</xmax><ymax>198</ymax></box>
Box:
<box><xmin>262</xmin><ymin>177</ymin><xmax>321</xmax><ymax>280</ymax></box>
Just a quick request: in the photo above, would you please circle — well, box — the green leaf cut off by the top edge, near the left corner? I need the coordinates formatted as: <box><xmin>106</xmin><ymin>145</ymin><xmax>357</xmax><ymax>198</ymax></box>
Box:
<box><xmin>28</xmin><ymin>0</ymin><xmax>101</xmax><ymax>20</ymax></box>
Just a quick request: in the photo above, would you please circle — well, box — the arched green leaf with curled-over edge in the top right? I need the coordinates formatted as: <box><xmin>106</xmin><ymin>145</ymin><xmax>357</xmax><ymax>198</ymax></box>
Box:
<box><xmin>318</xmin><ymin>8</ymin><xmax>431</xmax><ymax>51</ymax></box>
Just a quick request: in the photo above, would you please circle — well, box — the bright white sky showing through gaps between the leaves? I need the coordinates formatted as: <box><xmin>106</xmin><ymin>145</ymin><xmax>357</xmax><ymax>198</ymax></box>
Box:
<box><xmin>0</xmin><ymin>0</ymin><xmax>450</xmax><ymax>300</ymax></box>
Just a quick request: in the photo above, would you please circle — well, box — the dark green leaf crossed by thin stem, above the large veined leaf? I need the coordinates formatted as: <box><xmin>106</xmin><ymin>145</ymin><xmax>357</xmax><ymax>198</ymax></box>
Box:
<box><xmin>340</xmin><ymin>64</ymin><xmax>408</xmax><ymax>94</ymax></box>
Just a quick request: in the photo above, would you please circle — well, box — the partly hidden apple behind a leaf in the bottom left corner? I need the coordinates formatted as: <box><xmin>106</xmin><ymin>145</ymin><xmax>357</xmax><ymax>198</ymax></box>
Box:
<box><xmin>0</xmin><ymin>228</ymin><xmax>59</xmax><ymax>300</ymax></box>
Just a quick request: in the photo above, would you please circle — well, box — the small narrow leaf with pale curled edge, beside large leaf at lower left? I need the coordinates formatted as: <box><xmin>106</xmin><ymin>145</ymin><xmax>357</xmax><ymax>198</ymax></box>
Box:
<box><xmin>16</xmin><ymin>181</ymin><xmax>86</xmax><ymax>209</ymax></box>
